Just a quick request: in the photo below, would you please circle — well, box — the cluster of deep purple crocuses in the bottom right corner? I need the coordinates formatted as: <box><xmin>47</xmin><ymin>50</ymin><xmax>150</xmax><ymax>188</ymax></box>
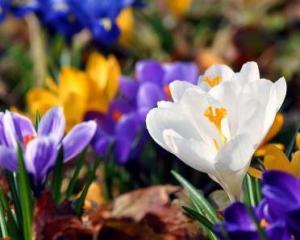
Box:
<box><xmin>215</xmin><ymin>171</ymin><xmax>300</xmax><ymax>240</ymax></box>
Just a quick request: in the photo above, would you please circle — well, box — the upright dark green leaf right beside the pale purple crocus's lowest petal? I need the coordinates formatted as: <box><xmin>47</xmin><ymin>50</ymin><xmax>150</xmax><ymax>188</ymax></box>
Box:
<box><xmin>52</xmin><ymin>146</ymin><xmax>64</xmax><ymax>204</ymax></box>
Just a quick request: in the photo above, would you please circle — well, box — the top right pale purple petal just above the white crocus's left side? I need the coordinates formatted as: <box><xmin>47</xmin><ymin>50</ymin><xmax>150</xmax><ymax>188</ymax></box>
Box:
<box><xmin>163</xmin><ymin>62</ymin><xmax>198</xmax><ymax>84</ymax></box>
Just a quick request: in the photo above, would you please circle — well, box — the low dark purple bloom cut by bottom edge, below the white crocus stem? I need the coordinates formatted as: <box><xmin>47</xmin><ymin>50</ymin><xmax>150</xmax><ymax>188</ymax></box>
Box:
<box><xmin>214</xmin><ymin>202</ymin><xmax>290</xmax><ymax>240</ymax></box>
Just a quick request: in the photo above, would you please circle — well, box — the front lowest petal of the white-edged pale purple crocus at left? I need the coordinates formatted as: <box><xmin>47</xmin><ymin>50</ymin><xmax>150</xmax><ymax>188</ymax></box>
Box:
<box><xmin>25</xmin><ymin>137</ymin><xmax>58</xmax><ymax>185</ymax></box>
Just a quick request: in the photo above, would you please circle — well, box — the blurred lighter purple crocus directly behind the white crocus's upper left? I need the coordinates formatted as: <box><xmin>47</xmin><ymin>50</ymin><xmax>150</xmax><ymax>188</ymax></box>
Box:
<box><xmin>135</xmin><ymin>60</ymin><xmax>198</xmax><ymax>119</ymax></box>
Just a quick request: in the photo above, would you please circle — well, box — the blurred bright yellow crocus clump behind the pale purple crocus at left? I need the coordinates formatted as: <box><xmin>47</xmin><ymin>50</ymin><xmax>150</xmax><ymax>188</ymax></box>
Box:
<box><xmin>27</xmin><ymin>53</ymin><xmax>121</xmax><ymax>130</ymax></box>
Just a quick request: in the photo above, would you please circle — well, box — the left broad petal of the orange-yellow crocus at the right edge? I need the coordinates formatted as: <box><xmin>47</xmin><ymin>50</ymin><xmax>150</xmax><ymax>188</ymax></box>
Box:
<box><xmin>264</xmin><ymin>145</ymin><xmax>290</xmax><ymax>172</ymax></box>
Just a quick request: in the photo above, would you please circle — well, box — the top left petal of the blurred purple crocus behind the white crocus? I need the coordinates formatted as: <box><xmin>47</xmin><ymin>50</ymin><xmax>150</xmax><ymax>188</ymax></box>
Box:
<box><xmin>135</xmin><ymin>60</ymin><xmax>164</xmax><ymax>86</ymax></box>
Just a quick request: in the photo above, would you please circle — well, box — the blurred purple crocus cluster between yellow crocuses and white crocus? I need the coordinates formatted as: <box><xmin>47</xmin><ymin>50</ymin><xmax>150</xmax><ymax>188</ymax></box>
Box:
<box><xmin>86</xmin><ymin>60</ymin><xmax>198</xmax><ymax>164</ymax></box>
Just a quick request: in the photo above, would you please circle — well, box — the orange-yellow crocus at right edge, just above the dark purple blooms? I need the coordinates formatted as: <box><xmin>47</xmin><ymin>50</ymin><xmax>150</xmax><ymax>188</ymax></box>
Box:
<box><xmin>248</xmin><ymin>145</ymin><xmax>300</xmax><ymax>178</ymax></box>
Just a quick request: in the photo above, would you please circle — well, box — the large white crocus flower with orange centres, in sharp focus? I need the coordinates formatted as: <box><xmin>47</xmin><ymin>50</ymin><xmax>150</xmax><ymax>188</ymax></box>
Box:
<box><xmin>146</xmin><ymin>62</ymin><xmax>286</xmax><ymax>200</ymax></box>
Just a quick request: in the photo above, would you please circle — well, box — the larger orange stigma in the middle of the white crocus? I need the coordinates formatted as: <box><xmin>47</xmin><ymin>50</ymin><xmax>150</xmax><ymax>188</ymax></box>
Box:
<box><xmin>204</xmin><ymin>106</ymin><xmax>227</xmax><ymax>149</ymax></box>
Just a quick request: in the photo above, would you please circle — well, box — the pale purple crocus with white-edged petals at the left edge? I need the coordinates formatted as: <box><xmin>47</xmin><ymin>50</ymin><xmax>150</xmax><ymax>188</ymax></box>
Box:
<box><xmin>0</xmin><ymin>107</ymin><xmax>96</xmax><ymax>187</ymax></box>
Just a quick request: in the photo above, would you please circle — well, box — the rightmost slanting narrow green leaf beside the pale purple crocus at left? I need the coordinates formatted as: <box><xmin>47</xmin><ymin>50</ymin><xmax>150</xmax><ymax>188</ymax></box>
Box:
<box><xmin>75</xmin><ymin>157</ymin><xmax>101</xmax><ymax>216</ymax></box>
